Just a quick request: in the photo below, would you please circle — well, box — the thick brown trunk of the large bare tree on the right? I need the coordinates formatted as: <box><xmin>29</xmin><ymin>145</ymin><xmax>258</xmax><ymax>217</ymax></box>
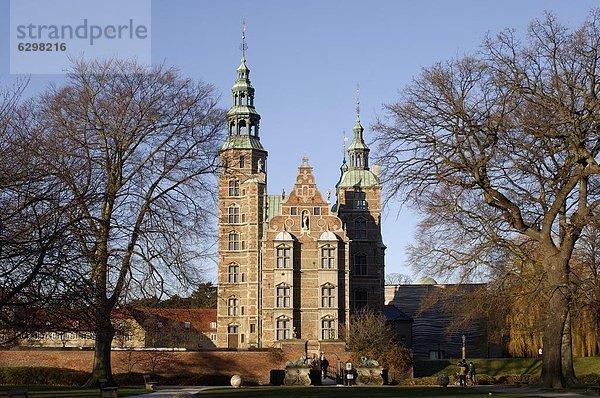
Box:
<box><xmin>539</xmin><ymin>255</ymin><xmax>568</xmax><ymax>388</ymax></box>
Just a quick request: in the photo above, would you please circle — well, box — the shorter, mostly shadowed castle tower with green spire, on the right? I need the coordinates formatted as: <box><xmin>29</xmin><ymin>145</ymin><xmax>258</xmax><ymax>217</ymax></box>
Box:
<box><xmin>335</xmin><ymin>91</ymin><xmax>385</xmax><ymax>313</ymax></box>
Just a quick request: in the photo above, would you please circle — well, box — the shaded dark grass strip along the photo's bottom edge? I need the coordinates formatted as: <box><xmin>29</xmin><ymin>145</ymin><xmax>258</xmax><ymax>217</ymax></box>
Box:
<box><xmin>196</xmin><ymin>386</ymin><xmax>522</xmax><ymax>398</ymax></box>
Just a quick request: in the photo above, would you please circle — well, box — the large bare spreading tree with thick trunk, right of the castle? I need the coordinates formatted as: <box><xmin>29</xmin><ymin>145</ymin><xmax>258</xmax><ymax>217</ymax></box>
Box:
<box><xmin>375</xmin><ymin>11</ymin><xmax>600</xmax><ymax>387</ymax></box>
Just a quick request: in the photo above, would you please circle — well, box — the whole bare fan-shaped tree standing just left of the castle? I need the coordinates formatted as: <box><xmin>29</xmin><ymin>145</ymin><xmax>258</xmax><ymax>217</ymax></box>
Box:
<box><xmin>29</xmin><ymin>60</ymin><xmax>224</xmax><ymax>383</ymax></box>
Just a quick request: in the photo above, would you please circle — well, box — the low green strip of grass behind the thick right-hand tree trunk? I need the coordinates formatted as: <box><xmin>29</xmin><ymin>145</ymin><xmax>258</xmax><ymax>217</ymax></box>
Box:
<box><xmin>414</xmin><ymin>357</ymin><xmax>600</xmax><ymax>377</ymax></box>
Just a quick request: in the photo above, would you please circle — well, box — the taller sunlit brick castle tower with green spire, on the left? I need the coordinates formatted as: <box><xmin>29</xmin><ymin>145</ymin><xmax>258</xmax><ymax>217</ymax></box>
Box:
<box><xmin>216</xmin><ymin>25</ymin><xmax>267</xmax><ymax>348</ymax></box>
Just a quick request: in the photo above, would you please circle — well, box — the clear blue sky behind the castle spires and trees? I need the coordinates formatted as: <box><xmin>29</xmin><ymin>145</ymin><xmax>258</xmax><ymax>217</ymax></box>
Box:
<box><xmin>0</xmin><ymin>0</ymin><xmax>600</xmax><ymax>284</ymax></box>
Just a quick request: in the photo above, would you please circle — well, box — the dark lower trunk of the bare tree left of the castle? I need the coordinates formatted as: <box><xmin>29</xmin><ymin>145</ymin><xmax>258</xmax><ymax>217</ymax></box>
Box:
<box><xmin>86</xmin><ymin>310</ymin><xmax>115</xmax><ymax>386</ymax></box>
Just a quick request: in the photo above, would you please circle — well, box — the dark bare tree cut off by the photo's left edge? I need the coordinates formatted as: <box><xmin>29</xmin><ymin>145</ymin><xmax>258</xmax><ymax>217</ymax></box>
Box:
<box><xmin>0</xmin><ymin>80</ymin><xmax>83</xmax><ymax>344</ymax></box>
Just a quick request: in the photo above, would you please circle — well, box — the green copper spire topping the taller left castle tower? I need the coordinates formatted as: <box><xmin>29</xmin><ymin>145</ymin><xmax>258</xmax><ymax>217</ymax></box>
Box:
<box><xmin>221</xmin><ymin>21</ymin><xmax>263</xmax><ymax>150</ymax></box>
